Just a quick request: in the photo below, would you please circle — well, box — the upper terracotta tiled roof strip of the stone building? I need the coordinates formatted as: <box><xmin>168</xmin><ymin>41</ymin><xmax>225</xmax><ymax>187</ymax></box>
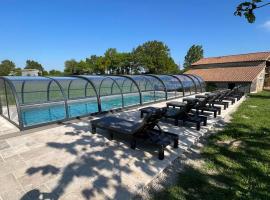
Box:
<box><xmin>192</xmin><ymin>52</ymin><xmax>270</xmax><ymax>65</ymax></box>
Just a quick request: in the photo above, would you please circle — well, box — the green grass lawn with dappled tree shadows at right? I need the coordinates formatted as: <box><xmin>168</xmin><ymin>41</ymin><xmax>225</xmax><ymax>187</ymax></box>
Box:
<box><xmin>153</xmin><ymin>92</ymin><xmax>270</xmax><ymax>200</ymax></box>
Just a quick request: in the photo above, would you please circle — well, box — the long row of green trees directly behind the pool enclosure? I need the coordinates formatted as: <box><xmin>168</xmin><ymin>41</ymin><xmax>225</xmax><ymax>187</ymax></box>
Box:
<box><xmin>65</xmin><ymin>41</ymin><xmax>179</xmax><ymax>75</ymax></box>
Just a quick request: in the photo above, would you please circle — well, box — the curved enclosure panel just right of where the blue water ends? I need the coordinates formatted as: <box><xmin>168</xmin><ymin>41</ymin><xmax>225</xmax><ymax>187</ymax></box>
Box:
<box><xmin>155</xmin><ymin>75</ymin><xmax>183</xmax><ymax>99</ymax></box>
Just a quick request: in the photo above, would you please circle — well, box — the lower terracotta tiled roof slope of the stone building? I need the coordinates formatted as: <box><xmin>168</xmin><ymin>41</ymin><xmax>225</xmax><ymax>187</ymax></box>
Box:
<box><xmin>186</xmin><ymin>63</ymin><xmax>265</xmax><ymax>82</ymax></box>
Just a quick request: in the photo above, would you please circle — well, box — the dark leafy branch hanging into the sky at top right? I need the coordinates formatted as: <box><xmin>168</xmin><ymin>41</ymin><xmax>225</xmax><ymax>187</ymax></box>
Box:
<box><xmin>234</xmin><ymin>0</ymin><xmax>270</xmax><ymax>23</ymax></box>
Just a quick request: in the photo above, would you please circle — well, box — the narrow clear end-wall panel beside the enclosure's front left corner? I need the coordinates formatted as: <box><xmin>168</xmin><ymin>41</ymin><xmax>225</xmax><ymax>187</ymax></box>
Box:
<box><xmin>6</xmin><ymin>84</ymin><xmax>19</xmax><ymax>124</ymax></box>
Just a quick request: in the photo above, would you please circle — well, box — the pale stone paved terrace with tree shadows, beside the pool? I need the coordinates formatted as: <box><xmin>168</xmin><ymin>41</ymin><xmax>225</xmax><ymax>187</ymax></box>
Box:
<box><xmin>0</xmin><ymin>95</ymin><xmax>245</xmax><ymax>200</ymax></box>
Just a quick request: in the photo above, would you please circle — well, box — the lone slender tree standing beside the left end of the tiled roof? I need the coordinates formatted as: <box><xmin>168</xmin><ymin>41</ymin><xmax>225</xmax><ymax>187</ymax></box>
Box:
<box><xmin>184</xmin><ymin>45</ymin><xmax>203</xmax><ymax>70</ymax></box>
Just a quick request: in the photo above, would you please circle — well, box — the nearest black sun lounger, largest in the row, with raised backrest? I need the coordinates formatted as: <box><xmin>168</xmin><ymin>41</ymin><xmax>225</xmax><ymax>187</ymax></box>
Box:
<box><xmin>91</xmin><ymin>109</ymin><xmax>178</xmax><ymax>160</ymax></box>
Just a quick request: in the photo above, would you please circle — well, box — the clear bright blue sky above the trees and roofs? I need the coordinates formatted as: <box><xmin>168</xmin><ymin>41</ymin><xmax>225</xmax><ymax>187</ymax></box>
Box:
<box><xmin>0</xmin><ymin>0</ymin><xmax>270</xmax><ymax>70</ymax></box>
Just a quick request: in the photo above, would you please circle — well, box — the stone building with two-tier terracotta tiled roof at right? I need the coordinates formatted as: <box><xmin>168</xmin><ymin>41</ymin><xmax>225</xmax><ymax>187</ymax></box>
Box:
<box><xmin>186</xmin><ymin>52</ymin><xmax>270</xmax><ymax>92</ymax></box>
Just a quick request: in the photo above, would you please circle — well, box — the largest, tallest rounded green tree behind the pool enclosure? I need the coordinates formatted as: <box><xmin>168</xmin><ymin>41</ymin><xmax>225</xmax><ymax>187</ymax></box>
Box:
<box><xmin>133</xmin><ymin>40</ymin><xmax>177</xmax><ymax>74</ymax></box>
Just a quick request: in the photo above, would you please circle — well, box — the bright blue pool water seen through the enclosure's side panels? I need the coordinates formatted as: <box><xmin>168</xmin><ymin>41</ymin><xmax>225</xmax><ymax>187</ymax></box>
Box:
<box><xmin>22</xmin><ymin>93</ymin><xmax>165</xmax><ymax>127</ymax></box>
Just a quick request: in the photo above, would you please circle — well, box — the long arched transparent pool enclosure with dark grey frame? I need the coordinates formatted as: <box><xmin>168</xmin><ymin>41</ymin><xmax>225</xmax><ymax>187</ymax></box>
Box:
<box><xmin>0</xmin><ymin>74</ymin><xmax>205</xmax><ymax>130</ymax></box>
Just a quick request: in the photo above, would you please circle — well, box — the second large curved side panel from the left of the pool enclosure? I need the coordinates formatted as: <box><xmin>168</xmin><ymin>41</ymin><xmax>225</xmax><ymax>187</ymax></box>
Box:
<box><xmin>52</xmin><ymin>77</ymin><xmax>98</xmax><ymax>118</ymax></box>
